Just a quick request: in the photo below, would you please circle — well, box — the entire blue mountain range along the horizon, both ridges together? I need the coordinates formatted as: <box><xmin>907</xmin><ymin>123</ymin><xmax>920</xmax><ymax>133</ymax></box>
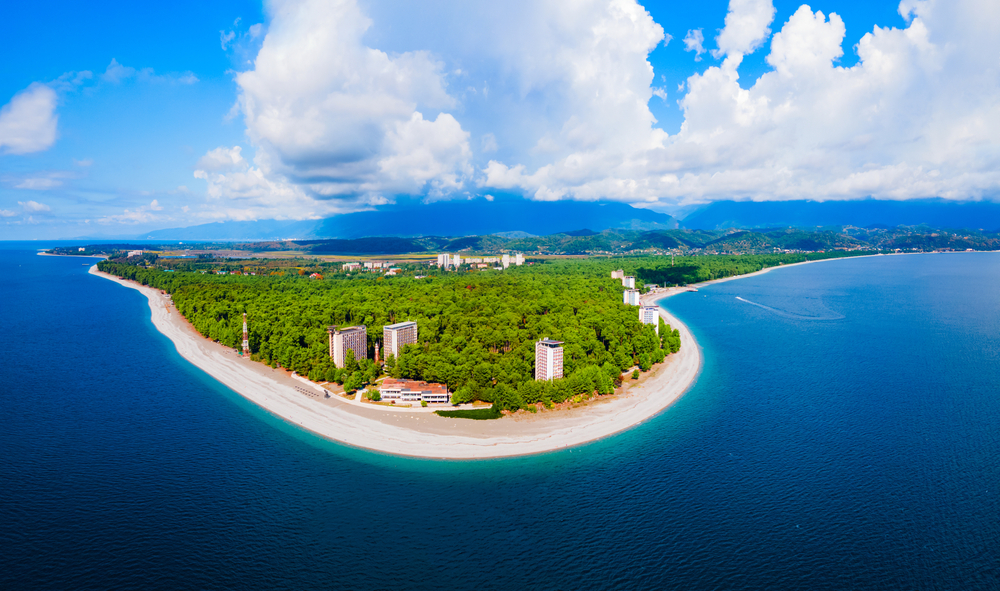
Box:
<box><xmin>115</xmin><ymin>199</ymin><xmax>1000</xmax><ymax>241</ymax></box>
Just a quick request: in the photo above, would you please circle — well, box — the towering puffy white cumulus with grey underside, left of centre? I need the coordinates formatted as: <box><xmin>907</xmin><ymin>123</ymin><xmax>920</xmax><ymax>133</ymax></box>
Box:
<box><xmin>236</xmin><ymin>0</ymin><xmax>472</xmax><ymax>200</ymax></box>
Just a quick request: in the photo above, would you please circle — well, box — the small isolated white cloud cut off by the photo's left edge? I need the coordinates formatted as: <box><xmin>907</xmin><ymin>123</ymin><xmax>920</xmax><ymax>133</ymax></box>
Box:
<box><xmin>0</xmin><ymin>82</ymin><xmax>59</xmax><ymax>154</ymax></box>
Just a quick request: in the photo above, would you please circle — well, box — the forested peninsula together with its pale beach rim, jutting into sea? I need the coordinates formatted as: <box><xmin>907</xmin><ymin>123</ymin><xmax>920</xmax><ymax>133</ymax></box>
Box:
<box><xmin>82</xmin><ymin>251</ymin><xmax>868</xmax><ymax>459</ymax></box>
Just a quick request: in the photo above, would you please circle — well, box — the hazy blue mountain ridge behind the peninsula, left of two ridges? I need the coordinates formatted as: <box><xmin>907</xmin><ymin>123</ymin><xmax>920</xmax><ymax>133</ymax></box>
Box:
<box><xmin>137</xmin><ymin>198</ymin><xmax>678</xmax><ymax>240</ymax></box>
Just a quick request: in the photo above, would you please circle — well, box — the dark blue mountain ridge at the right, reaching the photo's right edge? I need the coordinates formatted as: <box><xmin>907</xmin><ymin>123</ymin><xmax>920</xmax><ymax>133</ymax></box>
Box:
<box><xmin>681</xmin><ymin>199</ymin><xmax>1000</xmax><ymax>231</ymax></box>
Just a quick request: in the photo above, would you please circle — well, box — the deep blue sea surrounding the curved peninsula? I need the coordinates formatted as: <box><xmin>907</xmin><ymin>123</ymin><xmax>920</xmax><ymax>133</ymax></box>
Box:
<box><xmin>0</xmin><ymin>243</ymin><xmax>1000</xmax><ymax>590</ymax></box>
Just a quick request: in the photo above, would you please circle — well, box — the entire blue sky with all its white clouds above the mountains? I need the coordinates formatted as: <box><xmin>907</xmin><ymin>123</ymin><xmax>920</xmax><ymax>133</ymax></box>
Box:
<box><xmin>0</xmin><ymin>0</ymin><xmax>1000</xmax><ymax>239</ymax></box>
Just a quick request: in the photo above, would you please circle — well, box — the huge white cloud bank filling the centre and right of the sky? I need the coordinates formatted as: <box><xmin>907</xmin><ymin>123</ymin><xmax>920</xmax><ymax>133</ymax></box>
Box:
<box><xmin>196</xmin><ymin>0</ymin><xmax>1000</xmax><ymax>216</ymax></box>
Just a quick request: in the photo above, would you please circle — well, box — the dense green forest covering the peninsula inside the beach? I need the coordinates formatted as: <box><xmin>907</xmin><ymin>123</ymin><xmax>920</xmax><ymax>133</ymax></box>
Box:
<box><xmin>99</xmin><ymin>255</ymin><xmax>852</xmax><ymax>410</ymax></box>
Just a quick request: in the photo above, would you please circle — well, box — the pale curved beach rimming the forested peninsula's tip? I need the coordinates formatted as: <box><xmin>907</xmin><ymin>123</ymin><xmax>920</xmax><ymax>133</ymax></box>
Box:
<box><xmin>90</xmin><ymin>265</ymin><xmax>702</xmax><ymax>459</ymax></box>
